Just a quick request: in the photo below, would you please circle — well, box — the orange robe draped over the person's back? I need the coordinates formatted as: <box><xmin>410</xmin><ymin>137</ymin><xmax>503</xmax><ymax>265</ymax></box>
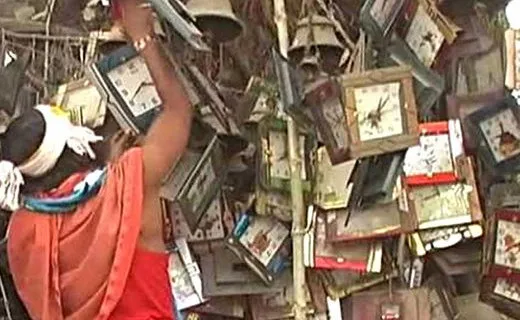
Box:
<box><xmin>8</xmin><ymin>148</ymin><xmax>143</xmax><ymax>320</ymax></box>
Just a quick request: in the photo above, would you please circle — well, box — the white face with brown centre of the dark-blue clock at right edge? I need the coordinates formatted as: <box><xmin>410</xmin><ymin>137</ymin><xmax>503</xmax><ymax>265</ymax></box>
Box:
<box><xmin>479</xmin><ymin>109</ymin><xmax>520</xmax><ymax>163</ymax></box>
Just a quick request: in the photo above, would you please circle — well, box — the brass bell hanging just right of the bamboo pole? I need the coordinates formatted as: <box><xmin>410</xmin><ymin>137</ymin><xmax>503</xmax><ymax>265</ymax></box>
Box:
<box><xmin>288</xmin><ymin>15</ymin><xmax>344</xmax><ymax>72</ymax></box>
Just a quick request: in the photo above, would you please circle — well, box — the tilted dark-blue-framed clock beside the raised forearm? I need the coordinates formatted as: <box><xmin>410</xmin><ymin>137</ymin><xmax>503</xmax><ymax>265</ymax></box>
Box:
<box><xmin>89</xmin><ymin>45</ymin><xmax>162</xmax><ymax>134</ymax></box>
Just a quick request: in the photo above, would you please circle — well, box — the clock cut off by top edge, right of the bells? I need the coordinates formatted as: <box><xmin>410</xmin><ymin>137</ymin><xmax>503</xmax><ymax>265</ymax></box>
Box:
<box><xmin>360</xmin><ymin>0</ymin><xmax>406</xmax><ymax>40</ymax></box>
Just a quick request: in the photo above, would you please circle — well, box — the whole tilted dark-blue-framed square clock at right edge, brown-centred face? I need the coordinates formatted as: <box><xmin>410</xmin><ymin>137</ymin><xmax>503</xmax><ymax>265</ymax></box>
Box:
<box><xmin>468</xmin><ymin>96</ymin><xmax>520</xmax><ymax>173</ymax></box>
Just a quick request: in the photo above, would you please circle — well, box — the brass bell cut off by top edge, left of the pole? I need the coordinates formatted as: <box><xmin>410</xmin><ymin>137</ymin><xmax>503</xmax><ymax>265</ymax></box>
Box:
<box><xmin>186</xmin><ymin>0</ymin><xmax>244</xmax><ymax>43</ymax></box>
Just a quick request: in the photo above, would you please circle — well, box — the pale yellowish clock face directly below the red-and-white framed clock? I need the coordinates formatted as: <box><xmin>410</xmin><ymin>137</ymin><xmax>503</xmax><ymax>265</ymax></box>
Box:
<box><xmin>413</xmin><ymin>183</ymin><xmax>473</xmax><ymax>223</ymax></box>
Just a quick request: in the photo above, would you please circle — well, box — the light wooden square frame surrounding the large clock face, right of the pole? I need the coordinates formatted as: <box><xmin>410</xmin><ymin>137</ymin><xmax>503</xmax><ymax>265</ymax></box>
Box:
<box><xmin>341</xmin><ymin>67</ymin><xmax>419</xmax><ymax>158</ymax></box>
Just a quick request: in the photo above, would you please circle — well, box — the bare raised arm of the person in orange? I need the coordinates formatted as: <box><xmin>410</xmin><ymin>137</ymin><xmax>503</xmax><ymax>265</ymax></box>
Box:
<box><xmin>120</xmin><ymin>0</ymin><xmax>192</xmax><ymax>189</ymax></box>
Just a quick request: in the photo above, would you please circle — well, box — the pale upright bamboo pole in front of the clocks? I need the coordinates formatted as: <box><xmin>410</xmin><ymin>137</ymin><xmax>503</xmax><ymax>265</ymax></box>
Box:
<box><xmin>273</xmin><ymin>0</ymin><xmax>307</xmax><ymax>320</ymax></box>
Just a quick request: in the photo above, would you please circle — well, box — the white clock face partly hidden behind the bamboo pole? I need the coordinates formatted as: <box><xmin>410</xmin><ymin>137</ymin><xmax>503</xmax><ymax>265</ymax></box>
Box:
<box><xmin>269</xmin><ymin>131</ymin><xmax>307</xmax><ymax>180</ymax></box>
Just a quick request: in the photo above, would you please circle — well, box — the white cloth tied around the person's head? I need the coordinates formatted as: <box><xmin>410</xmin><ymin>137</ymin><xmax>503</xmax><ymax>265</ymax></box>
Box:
<box><xmin>0</xmin><ymin>105</ymin><xmax>103</xmax><ymax>211</ymax></box>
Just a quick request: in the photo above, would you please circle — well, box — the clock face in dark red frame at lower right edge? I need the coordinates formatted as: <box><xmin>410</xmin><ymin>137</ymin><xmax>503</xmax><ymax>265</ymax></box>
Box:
<box><xmin>495</xmin><ymin>220</ymin><xmax>520</xmax><ymax>270</ymax></box>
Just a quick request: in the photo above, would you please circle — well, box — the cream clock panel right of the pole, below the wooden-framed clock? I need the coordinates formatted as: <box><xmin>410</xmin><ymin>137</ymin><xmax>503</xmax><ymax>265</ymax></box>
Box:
<box><xmin>314</xmin><ymin>147</ymin><xmax>357</xmax><ymax>210</ymax></box>
